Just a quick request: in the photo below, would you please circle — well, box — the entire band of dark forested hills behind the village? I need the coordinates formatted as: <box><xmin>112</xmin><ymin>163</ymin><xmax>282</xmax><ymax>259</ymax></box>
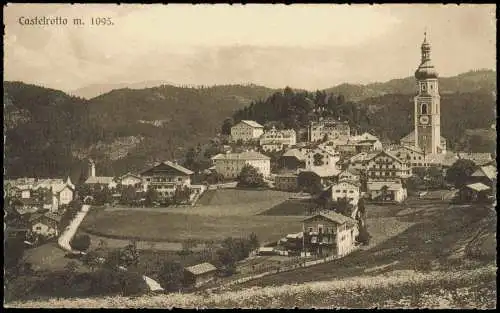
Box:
<box><xmin>4</xmin><ymin>71</ymin><xmax>496</xmax><ymax>181</ymax></box>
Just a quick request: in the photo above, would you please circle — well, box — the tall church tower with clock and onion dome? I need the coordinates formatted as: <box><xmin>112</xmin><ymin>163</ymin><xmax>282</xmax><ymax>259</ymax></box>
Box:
<box><xmin>414</xmin><ymin>33</ymin><xmax>446</xmax><ymax>154</ymax></box>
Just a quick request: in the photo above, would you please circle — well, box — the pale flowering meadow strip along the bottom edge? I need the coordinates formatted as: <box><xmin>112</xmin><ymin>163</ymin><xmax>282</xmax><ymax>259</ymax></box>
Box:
<box><xmin>5</xmin><ymin>266</ymin><xmax>496</xmax><ymax>309</ymax></box>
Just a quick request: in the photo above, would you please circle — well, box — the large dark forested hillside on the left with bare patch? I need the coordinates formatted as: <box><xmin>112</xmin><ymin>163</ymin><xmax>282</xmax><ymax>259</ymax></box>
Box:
<box><xmin>4</xmin><ymin>82</ymin><xmax>273</xmax><ymax>179</ymax></box>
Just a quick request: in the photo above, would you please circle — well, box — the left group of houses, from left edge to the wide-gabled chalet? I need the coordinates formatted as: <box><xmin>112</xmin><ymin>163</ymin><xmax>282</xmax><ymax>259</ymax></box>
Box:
<box><xmin>4</xmin><ymin>160</ymin><xmax>206</xmax><ymax>238</ymax></box>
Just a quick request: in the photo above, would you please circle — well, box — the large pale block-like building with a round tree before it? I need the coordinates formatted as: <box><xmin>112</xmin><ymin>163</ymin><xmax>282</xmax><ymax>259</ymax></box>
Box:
<box><xmin>212</xmin><ymin>151</ymin><xmax>271</xmax><ymax>179</ymax></box>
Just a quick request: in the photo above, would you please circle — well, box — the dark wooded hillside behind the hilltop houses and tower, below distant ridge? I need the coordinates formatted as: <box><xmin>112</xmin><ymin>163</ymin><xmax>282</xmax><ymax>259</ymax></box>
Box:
<box><xmin>233</xmin><ymin>88</ymin><xmax>496</xmax><ymax>152</ymax></box>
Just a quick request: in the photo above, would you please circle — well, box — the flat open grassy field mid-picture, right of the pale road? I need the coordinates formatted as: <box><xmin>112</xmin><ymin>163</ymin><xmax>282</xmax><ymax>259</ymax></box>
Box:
<box><xmin>81</xmin><ymin>211</ymin><xmax>302</xmax><ymax>242</ymax></box>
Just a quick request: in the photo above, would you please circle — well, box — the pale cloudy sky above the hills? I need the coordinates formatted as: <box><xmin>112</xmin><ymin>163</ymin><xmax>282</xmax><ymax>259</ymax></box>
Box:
<box><xmin>4</xmin><ymin>4</ymin><xmax>496</xmax><ymax>92</ymax></box>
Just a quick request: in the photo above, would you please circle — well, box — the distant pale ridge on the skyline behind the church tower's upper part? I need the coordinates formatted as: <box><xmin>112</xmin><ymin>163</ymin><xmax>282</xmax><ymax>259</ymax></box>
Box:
<box><xmin>325</xmin><ymin>70</ymin><xmax>497</xmax><ymax>101</ymax></box>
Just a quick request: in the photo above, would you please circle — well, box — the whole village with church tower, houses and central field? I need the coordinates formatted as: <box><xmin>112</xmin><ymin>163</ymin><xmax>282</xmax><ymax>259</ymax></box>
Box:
<box><xmin>4</xmin><ymin>34</ymin><xmax>497</xmax><ymax>298</ymax></box>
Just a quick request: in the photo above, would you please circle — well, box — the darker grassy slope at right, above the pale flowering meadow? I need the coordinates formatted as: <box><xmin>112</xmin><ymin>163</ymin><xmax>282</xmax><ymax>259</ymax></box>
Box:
<box><xmin>232</xmin><ymin>201</ymin><xmax>495</xmax><ymax>290</ymax></box>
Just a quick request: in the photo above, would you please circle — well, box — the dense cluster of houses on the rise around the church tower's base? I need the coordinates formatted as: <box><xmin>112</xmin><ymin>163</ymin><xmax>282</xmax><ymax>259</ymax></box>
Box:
<box><xmin>224</xmin><ymin>118</ymin><xmax>492</xmax><ymax>207</ymax></box>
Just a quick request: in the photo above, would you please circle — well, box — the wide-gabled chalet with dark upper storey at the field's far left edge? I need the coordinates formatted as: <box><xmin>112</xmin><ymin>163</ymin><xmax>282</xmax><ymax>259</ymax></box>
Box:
<box><xmin>140</xmin><ymin>161</ymin><xmax>194</xmax><ymax>197</ymax></box>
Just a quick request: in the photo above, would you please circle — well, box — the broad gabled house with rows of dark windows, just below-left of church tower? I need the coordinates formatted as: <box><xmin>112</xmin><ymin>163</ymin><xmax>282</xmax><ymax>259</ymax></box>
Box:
<box><xmin>368</xmin><ymin>151</ymin><xmax>411</xmax><ymax>181</ymax></box>
